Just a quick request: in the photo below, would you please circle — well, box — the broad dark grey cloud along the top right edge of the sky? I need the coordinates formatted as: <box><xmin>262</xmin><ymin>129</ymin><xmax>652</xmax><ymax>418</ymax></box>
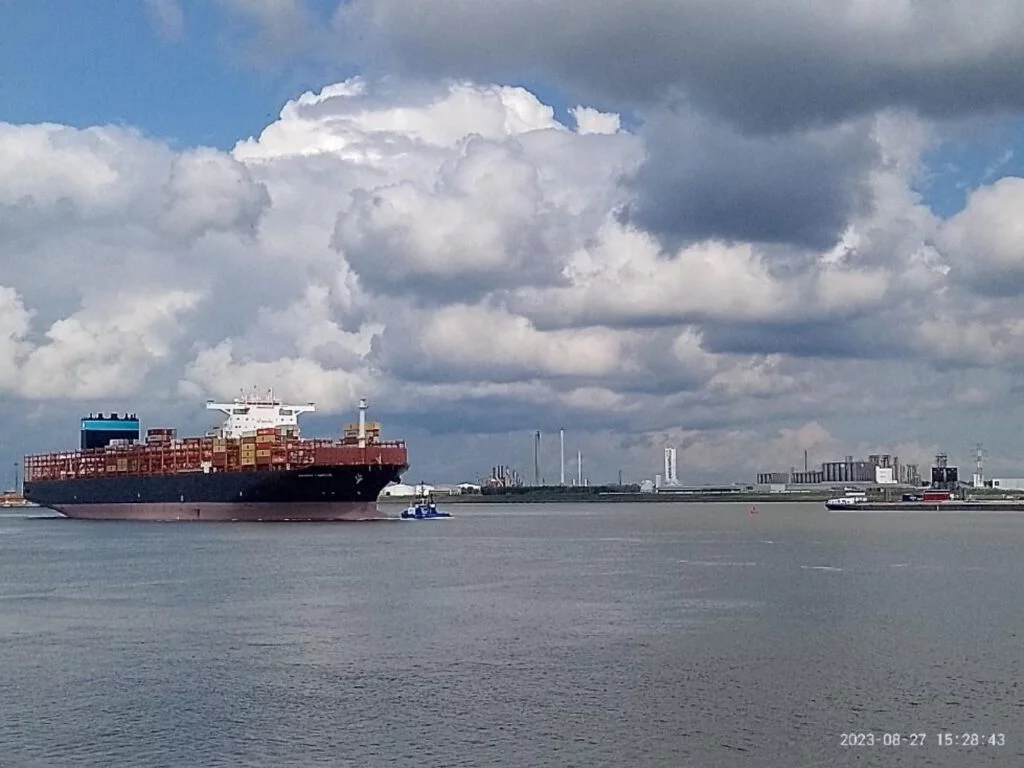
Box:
<box><xmin>335</xmin><ymin>0</ymin><xmax>1024</xmax><ymax>132</ymax></box>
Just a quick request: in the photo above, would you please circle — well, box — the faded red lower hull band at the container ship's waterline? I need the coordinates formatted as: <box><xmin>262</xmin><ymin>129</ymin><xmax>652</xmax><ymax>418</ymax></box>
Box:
<box><xmin>53</xmin><ymin>502</ymin><xmax>389</xmax><ymax>522</ymax></box>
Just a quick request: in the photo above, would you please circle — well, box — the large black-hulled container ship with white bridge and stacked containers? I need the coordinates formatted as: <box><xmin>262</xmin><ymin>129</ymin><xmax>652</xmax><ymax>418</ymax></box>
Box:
<box><xmin>24</xmin><ymin>392</ymin><xmax>409</xmax><ymax>521</ymax></box>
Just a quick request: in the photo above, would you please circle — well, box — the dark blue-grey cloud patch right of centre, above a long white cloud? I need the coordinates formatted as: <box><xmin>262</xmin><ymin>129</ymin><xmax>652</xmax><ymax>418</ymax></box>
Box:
<box><xmin>624</xmin><ymin>113</ymin><xmax>879</xmax><ymax>249</ymax></box>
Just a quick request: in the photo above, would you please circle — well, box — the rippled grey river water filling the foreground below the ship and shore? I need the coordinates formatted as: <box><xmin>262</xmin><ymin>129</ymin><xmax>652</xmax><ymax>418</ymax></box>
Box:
<box><xmin>0</xmin><ymin>503</ymin><xmax>1024</xmax><ymax>768</ymax></box>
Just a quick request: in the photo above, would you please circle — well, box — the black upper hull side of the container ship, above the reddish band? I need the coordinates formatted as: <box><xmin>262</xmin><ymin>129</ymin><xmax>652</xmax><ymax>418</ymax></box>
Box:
<box><xmin>25</xmin><ymin>465</ymin><xmax>404</xmax><ymax>516</ymax></box>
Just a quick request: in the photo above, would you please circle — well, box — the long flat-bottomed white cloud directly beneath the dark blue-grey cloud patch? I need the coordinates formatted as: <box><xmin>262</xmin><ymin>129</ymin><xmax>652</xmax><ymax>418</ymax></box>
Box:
<box><xmin>511</xmin><ymin>222</ymin><xmax>888</xmax><ymax>328</ymax></box>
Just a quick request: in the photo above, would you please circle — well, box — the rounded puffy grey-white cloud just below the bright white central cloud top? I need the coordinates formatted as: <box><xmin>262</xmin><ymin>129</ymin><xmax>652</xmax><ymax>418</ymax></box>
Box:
<box><xmin>333</xmin><ymin>139</ymin><xmax>571</xmax><ymax>296</ymax></box>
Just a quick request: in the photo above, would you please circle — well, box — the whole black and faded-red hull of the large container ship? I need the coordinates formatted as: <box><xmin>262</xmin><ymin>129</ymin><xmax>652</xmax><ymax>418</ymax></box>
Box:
<box><xmin>25</xmin><ymin>465</ymin><xmax>404</xmax><ymax>521</ymax></box>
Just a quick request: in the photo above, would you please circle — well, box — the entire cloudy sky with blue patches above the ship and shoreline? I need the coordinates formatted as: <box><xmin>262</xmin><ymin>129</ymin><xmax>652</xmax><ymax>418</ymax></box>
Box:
<box><xmin>0</xmin><ymin>0</ymin><xmax>1024</xmax><ymax>485</ymax></box>
